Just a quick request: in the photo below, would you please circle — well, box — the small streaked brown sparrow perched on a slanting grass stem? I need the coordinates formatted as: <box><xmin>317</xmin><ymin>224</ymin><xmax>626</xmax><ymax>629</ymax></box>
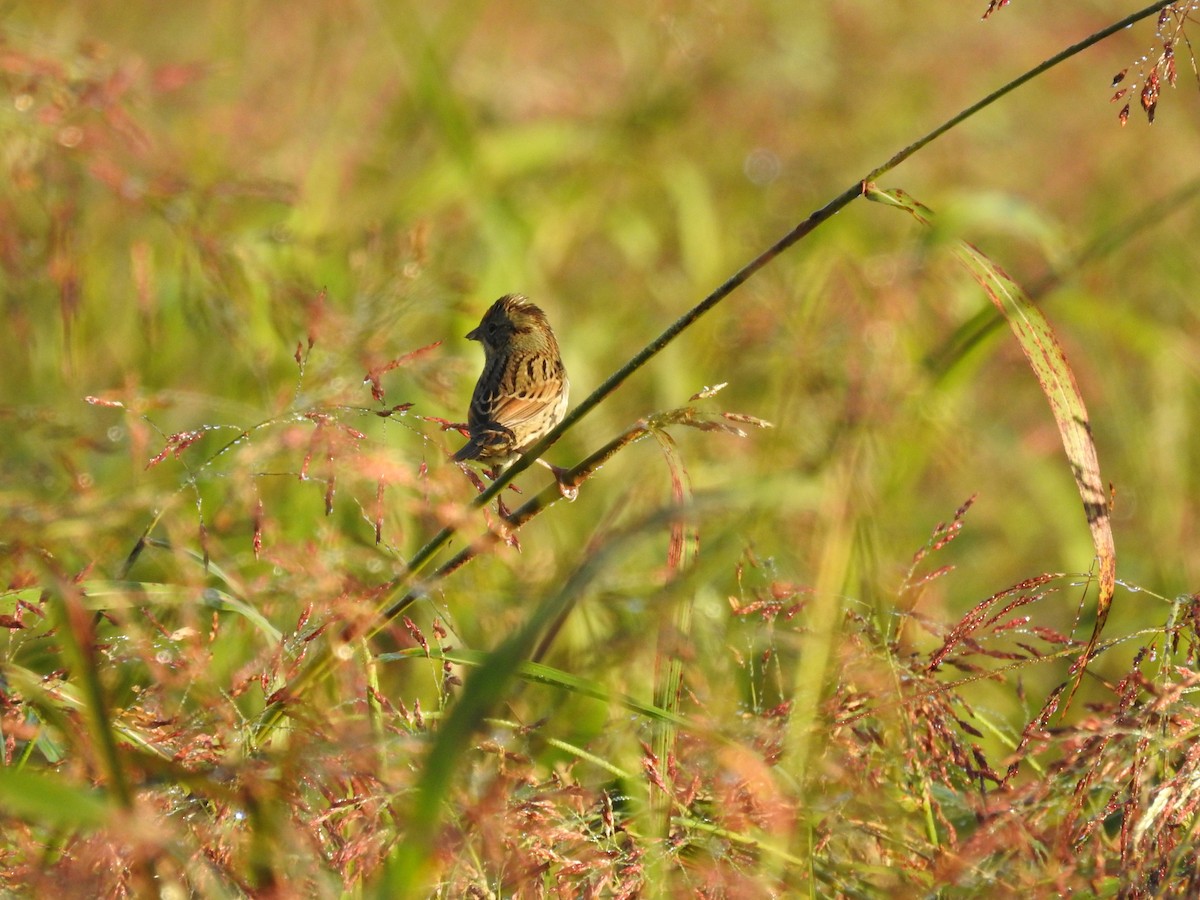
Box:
<box><xmin>454</xmin><ymin>294</ymin><xmax>570</xmax><ymax>469</ymax></box>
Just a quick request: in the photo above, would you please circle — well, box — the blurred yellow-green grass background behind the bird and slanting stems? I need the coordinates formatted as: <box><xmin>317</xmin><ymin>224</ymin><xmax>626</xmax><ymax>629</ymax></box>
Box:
<box><xmin>0</xmin><ymin>1</ymin><xmax>1200</xmax><ymax>897</ymax></box>
